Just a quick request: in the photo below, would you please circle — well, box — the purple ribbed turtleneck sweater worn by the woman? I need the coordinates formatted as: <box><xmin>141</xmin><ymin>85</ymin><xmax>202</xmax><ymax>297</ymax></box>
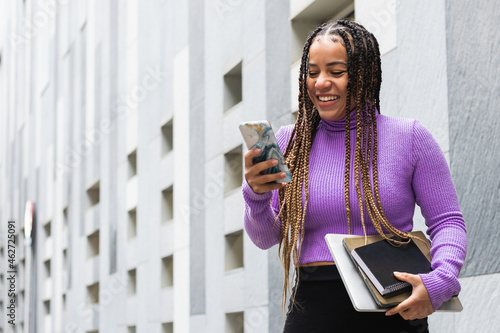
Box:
<box><xmin>242</xmin><ymin>115</ymin><xmax>467</xmax><ymax>309</ymax></box>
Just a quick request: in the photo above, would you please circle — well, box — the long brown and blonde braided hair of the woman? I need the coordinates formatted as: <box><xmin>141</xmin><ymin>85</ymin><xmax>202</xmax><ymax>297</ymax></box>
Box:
<box><xmin>277</xmin><ymin>20</ymin><xmax>413</xmax><ymax>310</ymax></box>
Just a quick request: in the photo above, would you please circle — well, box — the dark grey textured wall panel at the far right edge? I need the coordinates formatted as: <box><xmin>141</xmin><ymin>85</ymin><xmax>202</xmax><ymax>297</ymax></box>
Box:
<box><xmin>446</xmin><ymin>0</ymin><xmax>500</xmax><ymax>276</ymax></box>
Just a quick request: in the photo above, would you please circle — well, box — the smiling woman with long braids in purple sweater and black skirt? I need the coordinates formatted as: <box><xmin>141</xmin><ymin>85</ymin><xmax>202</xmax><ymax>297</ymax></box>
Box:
<box><xmin>243</xmin><ymin>21</ymin><xmax>466</xmax><ymax>333</ymax></box>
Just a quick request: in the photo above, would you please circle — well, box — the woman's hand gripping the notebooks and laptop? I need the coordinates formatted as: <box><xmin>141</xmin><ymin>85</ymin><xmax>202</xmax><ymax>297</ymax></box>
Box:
<box><xmin>385</xmin><ymin>272</ymin><xmax>434</xmax><ymax>320</ymax></box>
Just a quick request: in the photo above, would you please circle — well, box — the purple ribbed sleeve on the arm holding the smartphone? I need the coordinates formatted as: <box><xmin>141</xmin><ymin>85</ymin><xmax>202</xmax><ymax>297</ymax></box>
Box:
<box><xmin>242</xmin><ymin>125</ymin><xmax>293</xmax><ymax>249</ymax></box>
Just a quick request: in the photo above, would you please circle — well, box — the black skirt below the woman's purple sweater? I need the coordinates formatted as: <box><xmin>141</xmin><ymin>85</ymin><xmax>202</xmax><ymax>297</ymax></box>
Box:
<box><xmin>283</xmin><ymin>265</ymin><xmax>428</xmax><ymax>333</ymax></box>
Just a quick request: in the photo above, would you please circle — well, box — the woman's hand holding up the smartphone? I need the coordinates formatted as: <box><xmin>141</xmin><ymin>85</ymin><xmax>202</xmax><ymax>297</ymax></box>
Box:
<box><xmin>245</xmin><ymin>148</ymin><xmax>286</xmax><ymax>194</ymax></box>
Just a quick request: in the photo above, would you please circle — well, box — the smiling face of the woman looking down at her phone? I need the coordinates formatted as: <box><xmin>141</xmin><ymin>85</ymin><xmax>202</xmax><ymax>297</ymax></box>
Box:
<box><xmin>307</xmin><ymin>38</ymin><xmax>352</xmax><ymax>121</ymax></box>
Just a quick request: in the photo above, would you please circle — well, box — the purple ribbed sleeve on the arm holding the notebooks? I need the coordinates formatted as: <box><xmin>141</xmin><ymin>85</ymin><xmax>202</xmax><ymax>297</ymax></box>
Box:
<box><xmin>412</xmin><ymin>121</ymin><xmax>467</xmax><ymax>310</ymax></box>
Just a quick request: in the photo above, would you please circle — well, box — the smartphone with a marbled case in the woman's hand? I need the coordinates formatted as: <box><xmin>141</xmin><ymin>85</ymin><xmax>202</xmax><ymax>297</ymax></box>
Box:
<box><xmin>240</xmin><ymin>120</ymin><xmax>292</xmax><ymax>183</ymax></box>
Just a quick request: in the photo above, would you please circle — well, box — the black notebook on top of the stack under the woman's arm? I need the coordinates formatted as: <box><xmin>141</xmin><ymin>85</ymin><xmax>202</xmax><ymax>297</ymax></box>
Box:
<box><xmin>352</xmin><ymin>236</ymin><xmax>431</xmax><ymax>297</ymax></box>
